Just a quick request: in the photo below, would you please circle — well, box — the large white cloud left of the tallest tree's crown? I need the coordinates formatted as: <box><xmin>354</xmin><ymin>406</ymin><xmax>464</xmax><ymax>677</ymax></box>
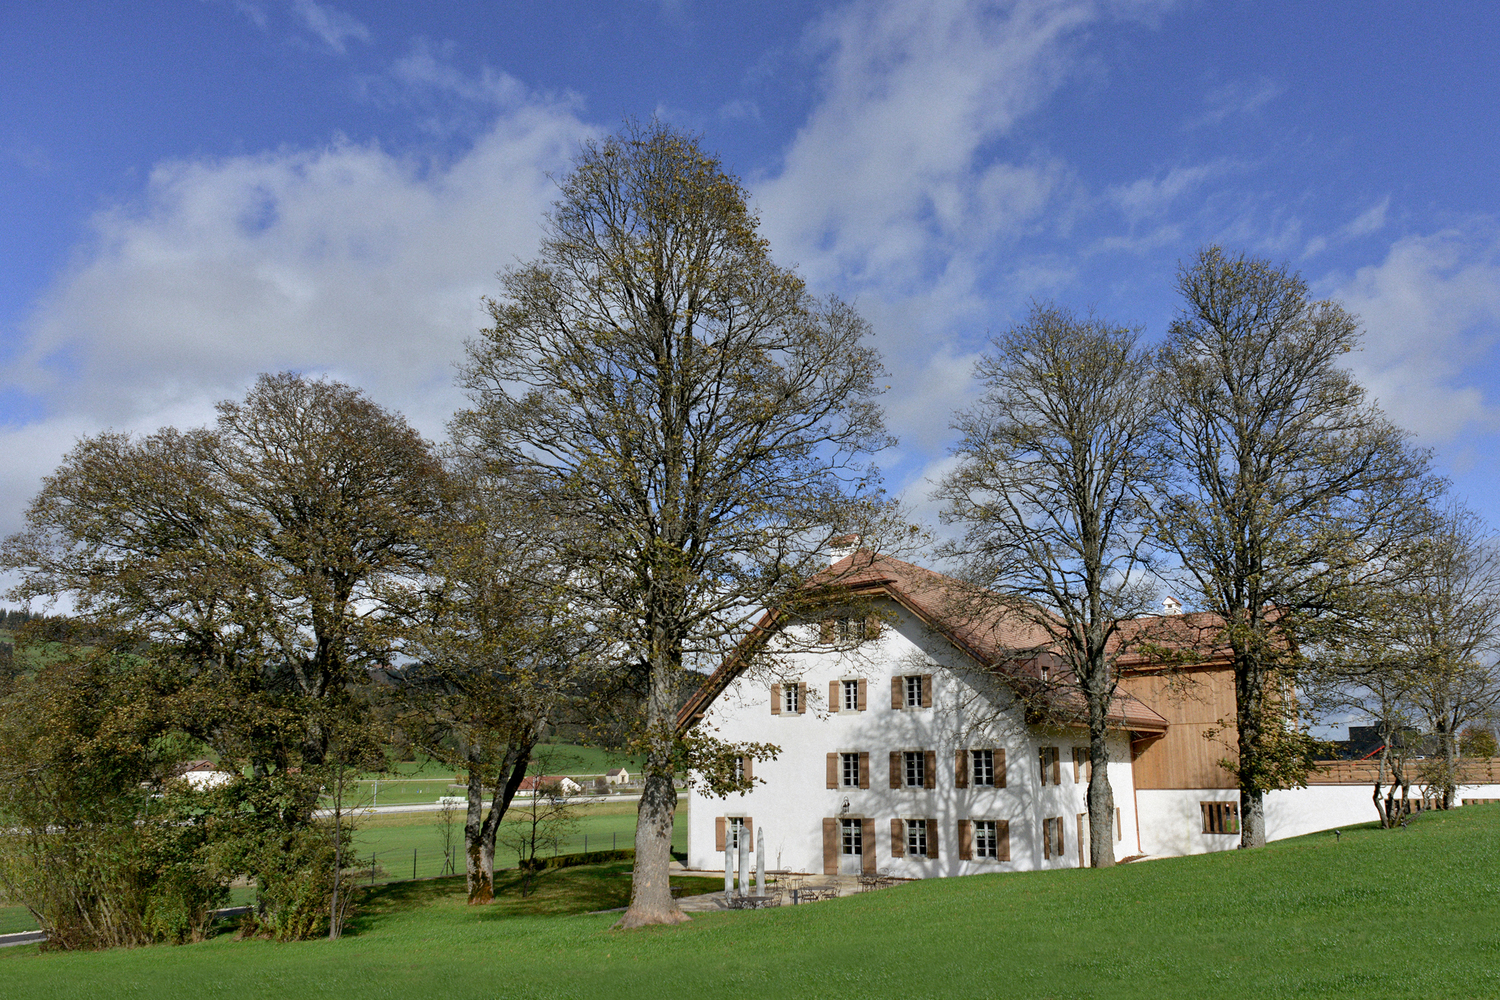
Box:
<box><xmin>0</xmin><ymin>100</ymin><xmax>591</xmax><ymax>534</ymax></box>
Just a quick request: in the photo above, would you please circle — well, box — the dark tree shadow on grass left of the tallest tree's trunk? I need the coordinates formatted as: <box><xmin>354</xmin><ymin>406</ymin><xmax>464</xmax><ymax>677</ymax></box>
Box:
<box><xmin>345</xmin><ymin>861</ymin><xmax>723</xmax><ymax>934</ymax></box>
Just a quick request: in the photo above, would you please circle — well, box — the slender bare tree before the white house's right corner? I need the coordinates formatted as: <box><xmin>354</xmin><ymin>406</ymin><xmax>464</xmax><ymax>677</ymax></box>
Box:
<box><xmin>938</xmin><ymin>304</ymin><xmax>1157</xmax><ymax>867</ymax></box>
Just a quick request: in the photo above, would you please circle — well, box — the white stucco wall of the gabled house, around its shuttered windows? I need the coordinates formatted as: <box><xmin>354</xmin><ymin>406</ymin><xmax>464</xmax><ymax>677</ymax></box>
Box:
<box><xmin>689</xmin><ymin>603</ymin><xmax>1140</xmax><ymax>879</ymax></box>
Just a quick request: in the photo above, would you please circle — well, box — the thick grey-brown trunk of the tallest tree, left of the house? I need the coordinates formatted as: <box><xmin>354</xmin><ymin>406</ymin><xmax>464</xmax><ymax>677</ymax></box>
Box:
<box><xmin>615</xmin><ymin>642</ymin><xmax>689</xmax><ymax>930</ymax></box>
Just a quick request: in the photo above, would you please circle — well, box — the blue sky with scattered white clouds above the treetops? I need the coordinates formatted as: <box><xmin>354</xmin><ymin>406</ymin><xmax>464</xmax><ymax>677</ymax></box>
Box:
<box><xmin>0</xmin><ymin>0</ymin><xmax>1500</xmax><ymax>605</ymax></box>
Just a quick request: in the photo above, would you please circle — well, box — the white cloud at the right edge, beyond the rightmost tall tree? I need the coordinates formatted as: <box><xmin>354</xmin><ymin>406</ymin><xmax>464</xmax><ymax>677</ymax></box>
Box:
<box><xmin>1334</xmin><ymin>229</ymin><xmax>1500</xmax><ymax>444</ymax></box>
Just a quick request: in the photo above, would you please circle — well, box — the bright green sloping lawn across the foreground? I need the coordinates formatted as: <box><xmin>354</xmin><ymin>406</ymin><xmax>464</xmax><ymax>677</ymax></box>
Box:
<box><xmin>0</xmin><ymin>807</ymin><xmax>1500</xmax><ymax>1000</ymax></box>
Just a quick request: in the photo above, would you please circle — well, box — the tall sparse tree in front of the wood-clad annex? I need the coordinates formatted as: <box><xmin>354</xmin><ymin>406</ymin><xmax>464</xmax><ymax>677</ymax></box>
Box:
<box><xmin>1157</xmin><ymin>246</ymin><xmax>1440</xmax><ymax>847</ymax></box>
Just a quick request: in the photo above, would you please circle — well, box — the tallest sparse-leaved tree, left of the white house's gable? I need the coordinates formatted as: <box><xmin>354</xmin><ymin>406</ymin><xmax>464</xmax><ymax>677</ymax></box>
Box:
<box><xmin>458</xmin><ymin>123</ymin><xmax>888</xmax><ymax>927</ymax></box>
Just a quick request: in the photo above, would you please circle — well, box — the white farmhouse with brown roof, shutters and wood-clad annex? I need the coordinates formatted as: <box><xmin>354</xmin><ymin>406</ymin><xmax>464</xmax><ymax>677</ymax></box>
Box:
<box><xmin>680</xmin><ymin>553</ymin><xmax>1500</xmax><ymax>879</ymax></box>
